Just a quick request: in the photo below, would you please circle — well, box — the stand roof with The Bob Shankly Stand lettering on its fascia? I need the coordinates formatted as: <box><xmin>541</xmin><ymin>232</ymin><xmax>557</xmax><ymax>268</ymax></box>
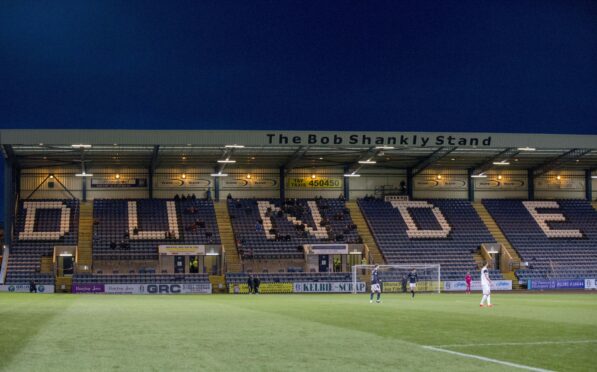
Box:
<box><xmin>0</xmin><ymin>129</ymin><xmax>597</xmax><ymax>175</ymax></box>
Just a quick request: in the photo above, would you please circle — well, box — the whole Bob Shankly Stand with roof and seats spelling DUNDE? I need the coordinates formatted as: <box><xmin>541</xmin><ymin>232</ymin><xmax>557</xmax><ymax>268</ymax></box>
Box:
<box><xmin>0</xmin><ymin>129</ymin><xmax>597</xmax><ymax>293</ymax></box>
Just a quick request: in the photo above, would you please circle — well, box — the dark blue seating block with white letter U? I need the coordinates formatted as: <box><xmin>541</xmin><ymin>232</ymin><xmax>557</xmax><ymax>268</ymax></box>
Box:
<box><xmin>93</xmin><ymin>199</ymin><xmax>220</xmax><ymax>260</ymax></box>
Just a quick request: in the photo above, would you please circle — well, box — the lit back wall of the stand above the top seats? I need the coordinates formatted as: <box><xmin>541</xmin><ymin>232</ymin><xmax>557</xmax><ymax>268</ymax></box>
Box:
<box><xmin>20</xmin><ymin>166</ymin><xmax>597</xmax><ymax>200</ymax></box>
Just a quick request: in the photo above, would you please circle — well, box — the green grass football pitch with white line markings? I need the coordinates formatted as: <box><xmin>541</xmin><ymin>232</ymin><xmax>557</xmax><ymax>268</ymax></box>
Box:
<box><xmin>0</xmin><ymin>293</ymin><xmax>597</xmax><ymax>371</ymax></box>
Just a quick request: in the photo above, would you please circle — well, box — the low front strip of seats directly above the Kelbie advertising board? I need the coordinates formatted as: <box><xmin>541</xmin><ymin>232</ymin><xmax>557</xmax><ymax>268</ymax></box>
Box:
<box><xmin>226</xmin><ymin>273</ymin><xmax>352</xmax><ymax>284</ymax></box>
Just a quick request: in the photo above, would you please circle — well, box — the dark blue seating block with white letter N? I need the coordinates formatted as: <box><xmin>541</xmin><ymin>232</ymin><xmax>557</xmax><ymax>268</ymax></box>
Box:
<box><xmin>228</xmin><ymin>199</ymin><xmax>360</xmax><ymax>259</ymax></box>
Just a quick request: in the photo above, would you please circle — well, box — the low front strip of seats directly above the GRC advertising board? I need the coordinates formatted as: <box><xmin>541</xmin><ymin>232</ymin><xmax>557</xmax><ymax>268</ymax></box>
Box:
<box><xmin>73</xmin><ymin>274</ymin><xmax>209</xmax><ymax>284</ymax></box>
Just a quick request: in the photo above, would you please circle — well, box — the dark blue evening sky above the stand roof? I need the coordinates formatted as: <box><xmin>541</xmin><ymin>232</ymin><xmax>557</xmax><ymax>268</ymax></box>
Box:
<box><xmin>0</xmin><ymin>0</ymin><xmax>597</xmax><ymax>133</ymax></box>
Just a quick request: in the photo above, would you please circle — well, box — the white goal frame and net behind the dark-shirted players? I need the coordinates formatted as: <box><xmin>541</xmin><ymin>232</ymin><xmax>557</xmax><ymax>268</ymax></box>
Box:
<box><xmin>352</xmin><ymin>264</ymin><xmax>441</xmax><ymax>293</ymax></box>
